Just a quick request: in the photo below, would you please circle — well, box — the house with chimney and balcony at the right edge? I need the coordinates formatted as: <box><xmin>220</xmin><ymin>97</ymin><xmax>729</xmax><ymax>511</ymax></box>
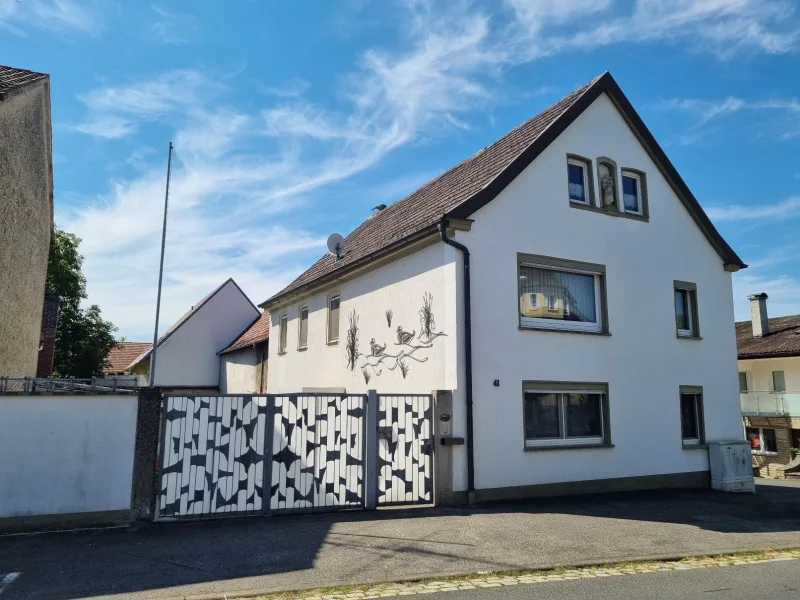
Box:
<box><xmin>736</xmin><ymin>294</ymin><xmax>800</xmax><ymax>478</ymax></box>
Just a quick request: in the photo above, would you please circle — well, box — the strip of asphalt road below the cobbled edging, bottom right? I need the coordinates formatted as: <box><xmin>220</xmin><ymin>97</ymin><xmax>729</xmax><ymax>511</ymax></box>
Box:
<box><xmin>418</xmin><ymin>560</ymin><xmax>800</xmax><ymax>600</ymax></box>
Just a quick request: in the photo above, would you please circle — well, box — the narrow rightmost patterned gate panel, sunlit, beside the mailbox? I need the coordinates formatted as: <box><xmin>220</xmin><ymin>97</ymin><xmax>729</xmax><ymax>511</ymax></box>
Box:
<box><xmin>378</xmin><ymin>394</ymin><xmax>433</xmax><ymax>505</ymax></box>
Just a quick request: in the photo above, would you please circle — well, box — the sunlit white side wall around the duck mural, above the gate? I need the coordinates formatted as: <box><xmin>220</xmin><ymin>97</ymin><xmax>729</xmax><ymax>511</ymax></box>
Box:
<box><xmin>267</xmin><ymin>242</ymin><xmax>466</xmax><ymax>489</ymax></box>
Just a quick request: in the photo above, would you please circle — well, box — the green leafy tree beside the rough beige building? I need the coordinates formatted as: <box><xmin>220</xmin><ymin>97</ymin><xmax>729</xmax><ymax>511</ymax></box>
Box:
<box><xmin>46</xmin><ymin>229</ymin><xmax>117</xmax><ymax>377</ymax></box>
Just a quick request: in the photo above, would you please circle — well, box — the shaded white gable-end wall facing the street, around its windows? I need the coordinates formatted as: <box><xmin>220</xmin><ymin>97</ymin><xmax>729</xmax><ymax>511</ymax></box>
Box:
<box><xmin>459</xmin><ymin>91</ymin><xmax>742</xmax><ymax>488</ymax></box>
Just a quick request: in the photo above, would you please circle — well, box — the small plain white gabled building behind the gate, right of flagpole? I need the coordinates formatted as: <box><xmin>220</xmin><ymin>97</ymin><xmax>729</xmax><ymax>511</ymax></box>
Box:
<box><xmin>128</xmin><ymin>279</ymin><xmax>261</xmax><ymax>390</ymax></box>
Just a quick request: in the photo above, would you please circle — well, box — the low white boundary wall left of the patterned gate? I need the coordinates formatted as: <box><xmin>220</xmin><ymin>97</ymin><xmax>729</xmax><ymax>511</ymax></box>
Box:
<box><xmin>0</xmin><ymin>396</ymin><xmax>137</xmax><ymax>518</ymax></box>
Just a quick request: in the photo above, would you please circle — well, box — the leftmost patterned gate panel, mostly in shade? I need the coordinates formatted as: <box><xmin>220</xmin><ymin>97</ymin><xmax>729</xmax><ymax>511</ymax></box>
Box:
<box><xmin>158</xmin><ymin>396</ymin><xmax>268</xmax><ymax>518</ymax></box>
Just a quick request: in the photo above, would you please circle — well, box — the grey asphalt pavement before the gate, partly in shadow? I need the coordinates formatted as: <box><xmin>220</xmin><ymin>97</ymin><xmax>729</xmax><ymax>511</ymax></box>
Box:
<box><xmin>0</xmin><ymin>482</ymin><xmax>800</xmax><ymax>600</ymax></box>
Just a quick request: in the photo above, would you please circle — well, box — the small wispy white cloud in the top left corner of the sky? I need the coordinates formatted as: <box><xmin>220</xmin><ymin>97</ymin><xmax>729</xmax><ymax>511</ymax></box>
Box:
<box><xmin>0</xmin><ymin>0</ymin><xmax>105</xmax><ymax>37</ymax></box>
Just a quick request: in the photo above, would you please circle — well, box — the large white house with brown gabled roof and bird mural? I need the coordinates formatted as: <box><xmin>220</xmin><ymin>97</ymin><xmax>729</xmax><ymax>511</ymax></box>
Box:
<box><xmin>262</xmin><ymin>73</ymin><xmax>746</xmax><ymax>500</ymax></box>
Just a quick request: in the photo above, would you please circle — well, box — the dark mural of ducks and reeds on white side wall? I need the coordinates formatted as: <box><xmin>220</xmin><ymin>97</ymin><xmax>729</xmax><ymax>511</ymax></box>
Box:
<box><xmin>354</xmin><ymin>292</ymin><xmax>447</xmax><ymax>383</ymax></box>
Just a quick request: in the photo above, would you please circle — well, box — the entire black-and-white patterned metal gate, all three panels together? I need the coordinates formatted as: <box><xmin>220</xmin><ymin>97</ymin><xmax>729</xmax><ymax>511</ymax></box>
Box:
<box><xmin>156</xmin><ymin>392</ymin><xmax>434</xmax><ymax>519</ymax></box>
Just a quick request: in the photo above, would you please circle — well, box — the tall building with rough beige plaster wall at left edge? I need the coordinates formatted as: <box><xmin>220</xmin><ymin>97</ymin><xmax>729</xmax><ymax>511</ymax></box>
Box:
<box><xmin>0</xmin><ymin>66</ymin><xmax>53</xmax><ymax>377</ymax></box>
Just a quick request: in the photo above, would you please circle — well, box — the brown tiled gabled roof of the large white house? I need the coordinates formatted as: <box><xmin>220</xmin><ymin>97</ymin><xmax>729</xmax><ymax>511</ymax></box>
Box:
<box><xmin>261</xmin><ymin>72</ymin><xmax>747</xmax><ymax>307</ymax></box>
